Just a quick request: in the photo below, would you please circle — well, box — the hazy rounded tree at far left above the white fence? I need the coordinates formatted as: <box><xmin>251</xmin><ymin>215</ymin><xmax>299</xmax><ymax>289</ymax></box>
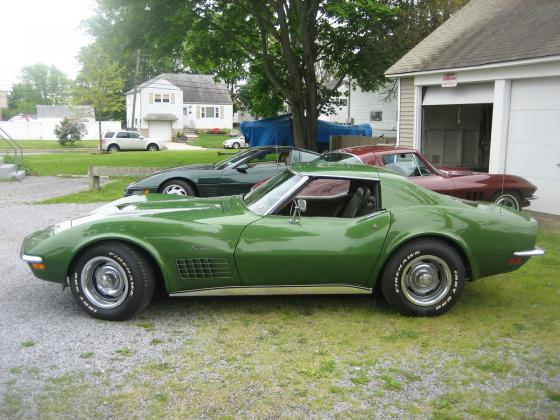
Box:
<box><xmin>6</xmin><ymin>63</ymin><xmax>71</xmax><ymax>118</ymax></box>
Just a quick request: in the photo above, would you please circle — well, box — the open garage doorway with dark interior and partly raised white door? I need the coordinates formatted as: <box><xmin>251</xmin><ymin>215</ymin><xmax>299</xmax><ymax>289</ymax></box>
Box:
<box><xmin>420</xmin><ymin>83</ymin><xmax>494</xmax><ymax>172</ymax></box>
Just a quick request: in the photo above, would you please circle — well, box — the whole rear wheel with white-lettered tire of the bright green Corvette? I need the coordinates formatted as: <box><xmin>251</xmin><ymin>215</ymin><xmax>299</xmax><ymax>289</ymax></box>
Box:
<box><xmin>381</xmin><ymin>239</ymin><xmax>465</xmax><ymax>316</ymax></box>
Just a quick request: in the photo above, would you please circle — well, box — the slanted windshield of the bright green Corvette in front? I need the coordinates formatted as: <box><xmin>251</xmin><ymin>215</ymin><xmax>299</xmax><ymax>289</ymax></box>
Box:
<box><xmin>243</xmin><ymin>171</ymin><xmax>302</xmax><ymax>216</ymax></box>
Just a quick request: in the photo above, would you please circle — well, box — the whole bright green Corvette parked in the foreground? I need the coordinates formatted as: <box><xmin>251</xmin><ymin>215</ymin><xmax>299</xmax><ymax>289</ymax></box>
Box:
<box><xmin>21</xmin><ymin>163</ymin><xmax>543</xmax><ymax>320</ymax></box>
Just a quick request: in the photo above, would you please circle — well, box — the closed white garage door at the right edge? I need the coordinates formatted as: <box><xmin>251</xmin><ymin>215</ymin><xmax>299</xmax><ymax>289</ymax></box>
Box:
<box><xmin>506</xmin><ymin>77</ymin><xmax>560</xmax><ymax>214</ymax></box>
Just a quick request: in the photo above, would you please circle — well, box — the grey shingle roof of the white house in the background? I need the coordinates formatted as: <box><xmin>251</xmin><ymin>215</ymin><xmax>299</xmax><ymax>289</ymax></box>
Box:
<box><xmin>131</xmin><ymin>73</ymin><xmax>233</xmax><ymax>105</ymax></box>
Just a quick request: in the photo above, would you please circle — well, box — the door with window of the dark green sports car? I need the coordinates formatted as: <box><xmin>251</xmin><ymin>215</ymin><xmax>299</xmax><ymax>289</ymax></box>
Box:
<box><xmin>220</xmin><ymin>148</ymin><xmax>290</xmax><ymax>195</ymax></box>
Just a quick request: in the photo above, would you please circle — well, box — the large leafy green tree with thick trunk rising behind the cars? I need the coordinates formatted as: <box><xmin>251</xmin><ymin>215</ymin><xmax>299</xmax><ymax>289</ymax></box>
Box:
<box><xmin>89</xmin><ymin>0</ymin><xmax>465</xmax><ymax>149</ymax></box>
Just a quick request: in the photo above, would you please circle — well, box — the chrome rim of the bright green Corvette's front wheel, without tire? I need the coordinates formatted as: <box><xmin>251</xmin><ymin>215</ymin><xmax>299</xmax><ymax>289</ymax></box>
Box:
<box><xmin>80</xmin><ymin>257</ymin><xmax>128</xmax><ymax>309</ymax></box>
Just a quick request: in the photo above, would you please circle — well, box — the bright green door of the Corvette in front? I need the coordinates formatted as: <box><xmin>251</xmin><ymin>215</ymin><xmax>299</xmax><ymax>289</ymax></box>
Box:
<box><xmin>235</xmin><ymin>179</ymin><xmax>390</xmax><ymax>287</ymax></box>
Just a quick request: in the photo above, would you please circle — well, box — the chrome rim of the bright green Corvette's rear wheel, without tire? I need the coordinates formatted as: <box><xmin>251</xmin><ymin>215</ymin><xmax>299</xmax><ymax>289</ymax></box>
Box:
<box><xmin>401</xmin><ymin>255</ymin><xmax>453</xmax><ymax>306</ymax></box>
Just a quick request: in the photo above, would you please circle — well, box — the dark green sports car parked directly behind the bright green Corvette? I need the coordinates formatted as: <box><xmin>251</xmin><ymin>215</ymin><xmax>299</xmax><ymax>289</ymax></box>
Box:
<box><xmin>124</xmin><ymin>146</ymin><xmax>320</xmax><ymax>197</ymax></box>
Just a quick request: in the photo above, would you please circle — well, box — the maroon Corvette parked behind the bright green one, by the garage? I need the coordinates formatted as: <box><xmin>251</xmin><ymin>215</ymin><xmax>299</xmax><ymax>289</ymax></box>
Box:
<box><xmin>320</xmin><ymin>146</ymin><xmax>537</xmax><ymax>210</ymax></box>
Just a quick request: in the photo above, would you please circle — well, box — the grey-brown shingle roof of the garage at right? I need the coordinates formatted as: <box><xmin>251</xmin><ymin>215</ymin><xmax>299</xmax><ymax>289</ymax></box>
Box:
<box><xmin>385</xmin><ymin>0</ymin><xmax>560</xmax><ymax>75</ymax></box>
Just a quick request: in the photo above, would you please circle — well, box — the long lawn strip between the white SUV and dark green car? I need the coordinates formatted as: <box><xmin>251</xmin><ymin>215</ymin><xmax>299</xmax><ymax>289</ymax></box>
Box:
<box><xmin>24</xmin><ymin>150</ymin><xmax>226</xmax><ymax>176</ymax></box>
